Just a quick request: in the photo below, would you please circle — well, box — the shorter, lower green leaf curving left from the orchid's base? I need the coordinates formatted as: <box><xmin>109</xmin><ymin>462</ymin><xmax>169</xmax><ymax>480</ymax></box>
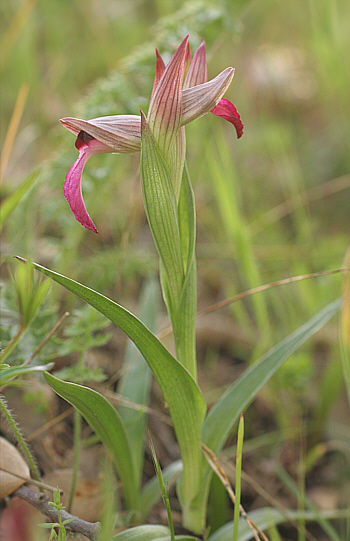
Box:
<box><xmin>44</xmin><ymin>372</ymin><xmax>140</xmax><ymax>509</ymax></box>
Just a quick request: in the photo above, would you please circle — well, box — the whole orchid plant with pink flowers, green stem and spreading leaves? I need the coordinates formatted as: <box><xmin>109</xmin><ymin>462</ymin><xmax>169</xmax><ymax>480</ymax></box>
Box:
<box><xmin>28</xmin><ymin>38</ymin><xmax>340</xmax><ymax>539</ymax></box>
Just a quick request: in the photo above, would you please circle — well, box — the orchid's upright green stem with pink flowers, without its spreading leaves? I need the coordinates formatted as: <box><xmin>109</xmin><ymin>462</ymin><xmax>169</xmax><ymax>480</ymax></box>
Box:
<box><xmin>56</xmin><ymin>36</ymin><xmax>243</xmax><ymax>533</ymax></box>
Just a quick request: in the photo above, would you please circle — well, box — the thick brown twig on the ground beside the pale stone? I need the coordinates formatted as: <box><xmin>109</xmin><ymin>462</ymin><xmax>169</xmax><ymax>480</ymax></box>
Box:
<box><xmin>13</xmin><ymin>485</ymin><xmax>101</xmax><ymax>541</ymax></box>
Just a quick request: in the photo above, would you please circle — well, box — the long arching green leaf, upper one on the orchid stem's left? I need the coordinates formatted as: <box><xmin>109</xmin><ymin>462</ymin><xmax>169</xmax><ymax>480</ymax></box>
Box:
<box><xmin>29</xmin><ymin>264</ymin><xmax>206</xmax><ymax>501</ymax></box>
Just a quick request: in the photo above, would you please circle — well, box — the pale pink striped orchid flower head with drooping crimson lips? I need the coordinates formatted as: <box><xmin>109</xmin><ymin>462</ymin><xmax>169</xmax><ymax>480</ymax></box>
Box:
<box><xmin>60</xmin><ymin>36</ymin><xmax>243</xmax><ymax>233</ymax></box>
